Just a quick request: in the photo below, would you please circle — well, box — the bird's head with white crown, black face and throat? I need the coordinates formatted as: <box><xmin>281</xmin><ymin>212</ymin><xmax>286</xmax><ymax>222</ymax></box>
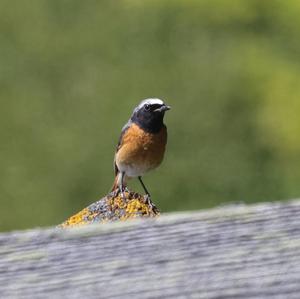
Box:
<box><xmin>131</xmin><ymin>99</ymin><xmax>171</xmax><ymax>133</ymax></box>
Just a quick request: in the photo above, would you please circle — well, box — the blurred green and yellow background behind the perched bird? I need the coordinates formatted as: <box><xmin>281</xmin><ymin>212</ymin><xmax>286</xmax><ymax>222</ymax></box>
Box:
<box><xmin>0</xmin><ymin>0</ymin><xmax>300</xmax><ymax>231</ymax></box>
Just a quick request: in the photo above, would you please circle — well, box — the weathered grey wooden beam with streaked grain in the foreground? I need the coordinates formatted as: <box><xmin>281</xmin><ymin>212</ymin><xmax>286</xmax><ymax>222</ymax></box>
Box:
<box><xmin>0</xmin><ymin>201</ymin><xmax>300</xmax><ymax>299</ymax></box>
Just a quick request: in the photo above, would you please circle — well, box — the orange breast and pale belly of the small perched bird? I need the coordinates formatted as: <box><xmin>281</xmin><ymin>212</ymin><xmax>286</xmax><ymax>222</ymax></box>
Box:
<box><xmin>116</xmin><ymin>124</ymin><xmax>167</xmax><ymax>176</ymax></box>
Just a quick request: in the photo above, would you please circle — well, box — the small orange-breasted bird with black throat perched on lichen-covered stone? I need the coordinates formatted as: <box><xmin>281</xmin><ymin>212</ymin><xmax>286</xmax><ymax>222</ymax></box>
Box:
<box><xmin>111</xmin><ymin>98</ymin><xmax>171</xmax><ymax>199</ymax></box>
